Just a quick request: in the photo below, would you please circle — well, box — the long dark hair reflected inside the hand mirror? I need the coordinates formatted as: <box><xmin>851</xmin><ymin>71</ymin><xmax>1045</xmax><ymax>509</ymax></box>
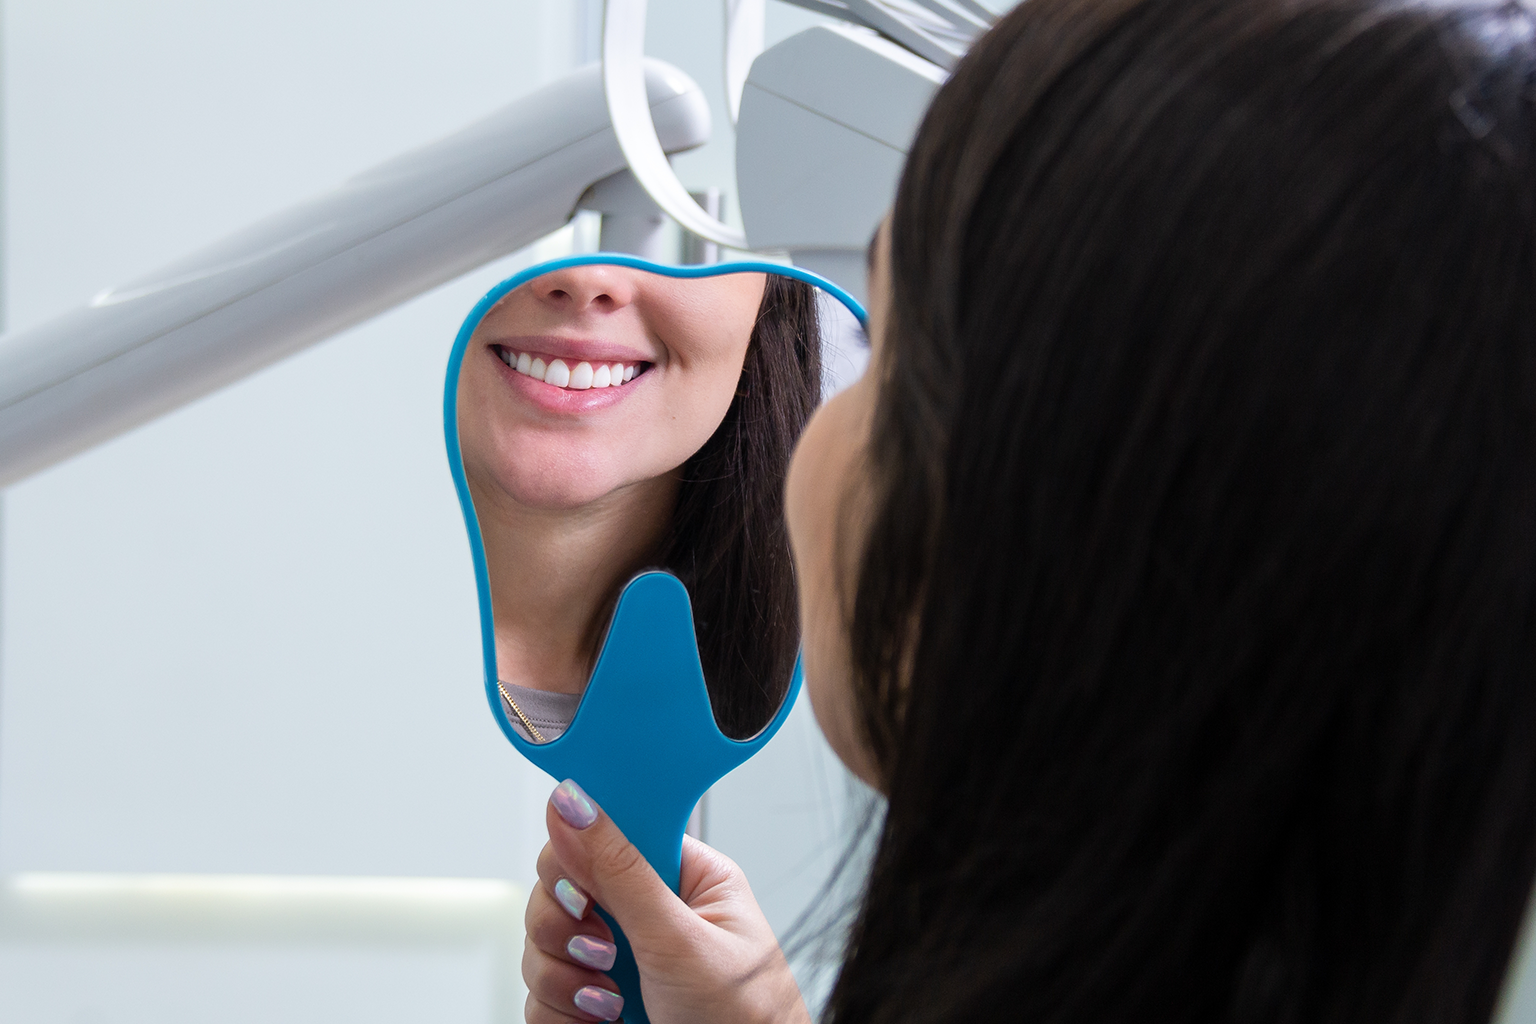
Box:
<box><xmin>659</xmin><ymin>275</ymin><xmax>822</xmax><ymax>740</ymax></box>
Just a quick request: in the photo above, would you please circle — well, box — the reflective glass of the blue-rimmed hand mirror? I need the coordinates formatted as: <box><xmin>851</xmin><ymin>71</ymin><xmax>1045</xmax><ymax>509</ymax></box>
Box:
<box><xmin>450</xmin><ymin>261</ymin><xmax>866</xmax><ymax>743</ymax></box>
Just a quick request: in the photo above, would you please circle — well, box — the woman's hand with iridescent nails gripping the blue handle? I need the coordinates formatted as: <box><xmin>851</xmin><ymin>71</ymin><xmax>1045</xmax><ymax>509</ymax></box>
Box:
<box><xmin>522</xmin><ymin>780</ymin><xmax>811</xmax><ymax>1024</ymax></box>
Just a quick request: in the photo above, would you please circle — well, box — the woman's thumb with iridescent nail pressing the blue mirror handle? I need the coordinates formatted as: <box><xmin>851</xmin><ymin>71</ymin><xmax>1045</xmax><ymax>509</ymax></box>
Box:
<box><xmin>545</xmin><ymin>778</ymin><xmax>693</xmax><ymax>956</ymax></box>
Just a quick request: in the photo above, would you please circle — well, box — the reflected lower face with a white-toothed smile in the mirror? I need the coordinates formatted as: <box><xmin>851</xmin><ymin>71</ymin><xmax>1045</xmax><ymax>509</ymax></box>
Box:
<box><xmin>458</xmin><ymin>264</ymin><xmax>765</xmax><ymax>511</ymax></box>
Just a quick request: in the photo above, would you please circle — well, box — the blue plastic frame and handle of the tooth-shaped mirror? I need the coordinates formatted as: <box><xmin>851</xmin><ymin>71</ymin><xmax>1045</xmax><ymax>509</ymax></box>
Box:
<box><xmin>442</xmin><ymin>252</ymin><xmax>868</xmax><ymax>1024</ymax></box>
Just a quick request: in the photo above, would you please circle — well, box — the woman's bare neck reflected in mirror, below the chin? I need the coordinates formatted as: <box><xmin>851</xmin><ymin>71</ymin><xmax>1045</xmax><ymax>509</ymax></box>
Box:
<box><xmin>472</xmin><ymin>474</ymin><xmax>677</xmax><ymax>694</ymax></box>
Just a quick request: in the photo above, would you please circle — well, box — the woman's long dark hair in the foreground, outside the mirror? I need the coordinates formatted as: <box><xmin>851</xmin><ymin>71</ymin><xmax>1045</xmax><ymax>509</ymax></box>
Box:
<box><xmin>828</xmin><ymin>0</ymin><xmax>1536</xmax><ymax>1024</ymax></box>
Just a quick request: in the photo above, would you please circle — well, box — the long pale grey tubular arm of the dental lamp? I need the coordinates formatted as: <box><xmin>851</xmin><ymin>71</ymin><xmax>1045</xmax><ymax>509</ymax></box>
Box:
<box><xmin>0</xmin><ymin>60</ymin><xmax>710</xmax><ymax>487</ymax></box>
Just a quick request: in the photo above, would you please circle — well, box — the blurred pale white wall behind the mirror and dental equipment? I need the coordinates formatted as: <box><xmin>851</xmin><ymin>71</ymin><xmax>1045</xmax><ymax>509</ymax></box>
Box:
<box><xmin>0</xmin><ymin>0</ymin><xmax>866</xmax><ymax>1024</ymax></box>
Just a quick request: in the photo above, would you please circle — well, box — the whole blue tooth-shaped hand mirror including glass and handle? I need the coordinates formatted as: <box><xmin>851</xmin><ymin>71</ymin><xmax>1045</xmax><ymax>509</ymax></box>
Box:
<box><xmin>442</xmin><ymin>253</ymin><xmax>865</xmax><ymax>1024</ymax></box>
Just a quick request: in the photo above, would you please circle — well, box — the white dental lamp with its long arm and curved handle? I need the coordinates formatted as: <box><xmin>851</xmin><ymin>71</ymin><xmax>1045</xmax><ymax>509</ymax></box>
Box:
<box><xmin>0</xmin><ymin>0</ymin><xmax>995</xmax><ymax>487</ymax></box>
